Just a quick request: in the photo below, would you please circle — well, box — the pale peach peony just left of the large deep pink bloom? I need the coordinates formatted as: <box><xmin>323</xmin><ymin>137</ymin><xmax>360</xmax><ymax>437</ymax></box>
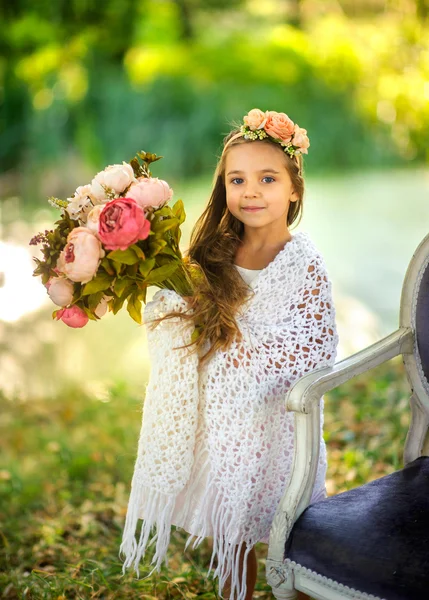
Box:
<box><xmin>57</xmin><ymin>227</ymin><xmax>105</xmax><ymax>283</ymax></box>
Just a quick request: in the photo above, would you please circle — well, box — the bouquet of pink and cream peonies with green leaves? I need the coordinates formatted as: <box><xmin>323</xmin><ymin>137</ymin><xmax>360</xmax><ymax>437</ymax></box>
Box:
<box><xmin>30</xmin><ymin>151</ymin><xmax>193</xmax><ymax>327</ymax></box>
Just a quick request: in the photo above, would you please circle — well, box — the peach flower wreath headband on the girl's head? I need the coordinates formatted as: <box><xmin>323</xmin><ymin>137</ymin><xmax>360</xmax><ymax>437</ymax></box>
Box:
<box><xmin>222</xmin><ymin>108</ymin><xmax>310</xmax><ymax>157</ymax></box>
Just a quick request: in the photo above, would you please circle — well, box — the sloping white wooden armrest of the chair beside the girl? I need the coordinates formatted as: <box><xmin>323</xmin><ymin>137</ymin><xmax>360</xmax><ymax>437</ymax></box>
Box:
<box><xmin>285</xmin><ymin>327</ymin><xmax>414</xmax><ymax>413</ymax></box>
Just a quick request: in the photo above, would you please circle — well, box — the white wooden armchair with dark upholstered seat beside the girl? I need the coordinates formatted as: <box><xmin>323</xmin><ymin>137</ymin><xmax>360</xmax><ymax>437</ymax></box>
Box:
<box><xmin>266</xmin><ymin>235</ymin><xmax>429</xmax><ymax>600</ymax></box>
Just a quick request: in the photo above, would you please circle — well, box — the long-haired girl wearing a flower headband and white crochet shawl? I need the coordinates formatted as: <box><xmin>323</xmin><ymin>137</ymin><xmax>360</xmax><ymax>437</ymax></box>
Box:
<box><xmin>121</xmin><ymin>109</ymin><xmax>338</xmax><ymax>600</ymax></box>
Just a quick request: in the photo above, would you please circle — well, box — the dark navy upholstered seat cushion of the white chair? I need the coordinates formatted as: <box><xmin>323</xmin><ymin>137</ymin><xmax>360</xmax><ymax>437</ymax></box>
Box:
<box><xmin>285</xmin><ymin>456</ymin><xmax>429</xmax><ymax>600</ymax></box>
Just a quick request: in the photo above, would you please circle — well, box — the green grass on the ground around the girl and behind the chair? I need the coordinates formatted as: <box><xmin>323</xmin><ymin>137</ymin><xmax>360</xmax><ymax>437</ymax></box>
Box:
<box><xmin>0</xmin><ymin>359</ymin><xmax>410</xmax><ymax>600</ymax></box>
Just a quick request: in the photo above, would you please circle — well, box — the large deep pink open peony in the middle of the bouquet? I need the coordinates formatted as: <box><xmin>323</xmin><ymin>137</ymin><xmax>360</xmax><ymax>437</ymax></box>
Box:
<box><xmin>98</xmin><ymin>197</ymin><xmax>150</xmax><ymax>250</ymax></box>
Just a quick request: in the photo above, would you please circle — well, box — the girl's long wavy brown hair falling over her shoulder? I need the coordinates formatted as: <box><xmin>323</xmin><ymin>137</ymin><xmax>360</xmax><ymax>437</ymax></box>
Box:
<box><xmin>146</xmin><ymin>127</ymin><xmax>304</xmax><ymax>364</ymax></box>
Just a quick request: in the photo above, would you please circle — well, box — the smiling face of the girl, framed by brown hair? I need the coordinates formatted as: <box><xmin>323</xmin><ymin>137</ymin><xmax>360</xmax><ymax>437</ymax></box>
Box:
<box><xmin>225</xmin><ymin>141</ymin><xmax>298</xmax><ymax>232</ymax></box>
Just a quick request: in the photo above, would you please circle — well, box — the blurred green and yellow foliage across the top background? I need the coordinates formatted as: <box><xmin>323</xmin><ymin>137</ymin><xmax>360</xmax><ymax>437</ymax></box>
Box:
<box><xmin>0</xmin><ymin>0</ymin><xmax>429</xmax><ymax>192</ymax></box>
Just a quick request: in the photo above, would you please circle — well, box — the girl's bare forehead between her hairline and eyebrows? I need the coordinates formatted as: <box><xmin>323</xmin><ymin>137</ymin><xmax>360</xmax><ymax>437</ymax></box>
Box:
<box><xmin>225</xmin><ymin>141</ymin><xmax>285</xmax><ymax>173</ymax></box>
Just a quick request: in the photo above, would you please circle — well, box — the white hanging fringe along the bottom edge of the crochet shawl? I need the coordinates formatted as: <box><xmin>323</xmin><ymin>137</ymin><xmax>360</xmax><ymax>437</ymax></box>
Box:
<box><xmin>119</xmin><ymin>468</ymin><xmax>254</xmax><ymax>600</ymax></box>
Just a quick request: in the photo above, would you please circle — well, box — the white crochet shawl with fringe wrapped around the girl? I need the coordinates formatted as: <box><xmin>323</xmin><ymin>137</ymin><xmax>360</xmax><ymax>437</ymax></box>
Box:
<box><xmin>120</xmin><ymin>231</ymin><xmax>338</xmax><ymax>600</ymax></box>
